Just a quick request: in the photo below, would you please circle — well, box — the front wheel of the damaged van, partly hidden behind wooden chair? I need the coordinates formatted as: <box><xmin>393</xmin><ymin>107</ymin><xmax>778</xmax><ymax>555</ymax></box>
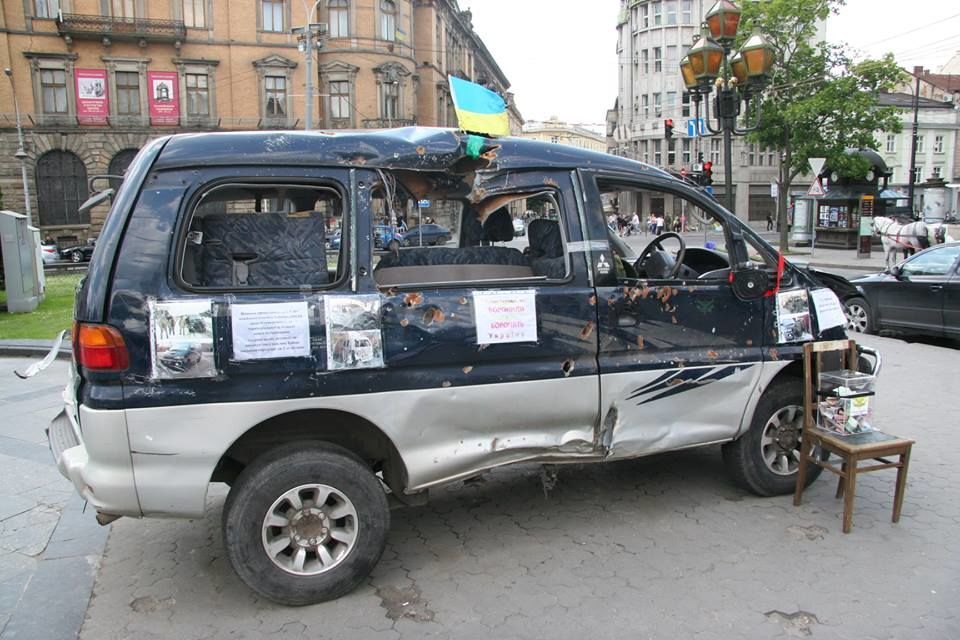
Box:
<box><xmin>722</xmin><ymin>378</ymin><xmax>823</xmax><ymax>496</ymax></box>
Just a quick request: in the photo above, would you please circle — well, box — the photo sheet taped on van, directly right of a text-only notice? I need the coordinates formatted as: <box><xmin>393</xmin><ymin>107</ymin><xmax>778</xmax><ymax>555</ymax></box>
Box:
<box><xmin>324</xmin><ymin>294</ymin><xmax>383</xmax><ymax>371</ymax></box>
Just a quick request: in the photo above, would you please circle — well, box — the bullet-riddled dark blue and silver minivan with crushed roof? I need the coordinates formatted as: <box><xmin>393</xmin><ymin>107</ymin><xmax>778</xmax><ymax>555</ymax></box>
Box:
<box><xmin>49</xmin><ymin>128</ymin><xmax>872</xmax><ymax>605</ymax></box>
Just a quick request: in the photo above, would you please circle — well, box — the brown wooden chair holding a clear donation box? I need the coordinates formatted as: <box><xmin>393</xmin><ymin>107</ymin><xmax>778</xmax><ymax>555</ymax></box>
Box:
<box><xmin>793</xmin><ymin>340</ymin><xmax>913</xmax><ymax>533</ymax></box>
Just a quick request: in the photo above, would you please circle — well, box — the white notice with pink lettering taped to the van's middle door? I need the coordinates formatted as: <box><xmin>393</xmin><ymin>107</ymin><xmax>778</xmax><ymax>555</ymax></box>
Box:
<box><xmin>473</xmin><ymin>289</ymin><xmax>537</xmax><ymax>344</ymax></box>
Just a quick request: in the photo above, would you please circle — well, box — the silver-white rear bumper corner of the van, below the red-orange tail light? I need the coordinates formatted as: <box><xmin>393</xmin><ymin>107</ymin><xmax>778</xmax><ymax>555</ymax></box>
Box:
<box><xmin>47</xmin><ymin>399</ymin><xmax>141</xmax><ymax>516</ymax></box>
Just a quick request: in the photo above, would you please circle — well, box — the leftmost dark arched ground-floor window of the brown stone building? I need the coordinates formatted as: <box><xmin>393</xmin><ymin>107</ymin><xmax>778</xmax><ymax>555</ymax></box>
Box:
<box><xmin>36</xmin><ymin>150</ymin><xmax>90</xmax><ymax>226</ymax></box>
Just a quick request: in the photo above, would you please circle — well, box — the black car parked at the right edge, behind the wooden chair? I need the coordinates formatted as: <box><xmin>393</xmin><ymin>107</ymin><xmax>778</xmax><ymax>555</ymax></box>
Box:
<box><xmin>811</xmin><ymin>242</ymin><xmax>960</xmax><ymax>338</ymax></box>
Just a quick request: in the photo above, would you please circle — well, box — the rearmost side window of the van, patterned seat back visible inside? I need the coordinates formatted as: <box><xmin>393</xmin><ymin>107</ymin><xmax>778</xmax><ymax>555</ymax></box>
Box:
<box><xmin>179</xmin><ymin>184</ymin><xmax>346</xmax><ymax>289</ymax></box>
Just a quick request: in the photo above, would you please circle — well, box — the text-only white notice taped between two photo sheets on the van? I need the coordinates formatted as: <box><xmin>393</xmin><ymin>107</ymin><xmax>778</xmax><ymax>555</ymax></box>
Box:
<box><xmin>230</xmin><ymin>301</ymin><xmax>310</xmax><ymax>360</ymax></box>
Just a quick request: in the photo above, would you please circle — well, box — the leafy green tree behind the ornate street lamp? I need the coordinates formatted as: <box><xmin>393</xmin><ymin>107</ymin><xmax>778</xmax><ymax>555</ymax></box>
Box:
<box><xmin>737</xmin><ymin>0</ymin><xmax>903</xmax><ymax>251</ymax></box>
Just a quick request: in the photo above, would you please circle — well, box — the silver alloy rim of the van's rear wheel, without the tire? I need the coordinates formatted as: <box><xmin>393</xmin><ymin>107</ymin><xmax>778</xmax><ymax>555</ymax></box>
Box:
<box><xmin>261</xmin><ymin>484</ymin><xmax>359</xmax><ymax>576</ymax></box>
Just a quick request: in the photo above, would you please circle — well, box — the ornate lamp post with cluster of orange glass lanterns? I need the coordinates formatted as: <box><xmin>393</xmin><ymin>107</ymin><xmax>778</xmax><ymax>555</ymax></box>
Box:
<box><xmin>680</xmin><ymin>0</ymin><xmax>776</xmax><ymax>212</ymax></box>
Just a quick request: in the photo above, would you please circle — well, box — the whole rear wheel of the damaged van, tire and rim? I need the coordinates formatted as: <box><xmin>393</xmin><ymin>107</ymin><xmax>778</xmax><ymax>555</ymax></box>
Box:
<box><xmin>223</xmin><ymin>441</ymin><xmax>390</xmax><ymax>606</ymax></box>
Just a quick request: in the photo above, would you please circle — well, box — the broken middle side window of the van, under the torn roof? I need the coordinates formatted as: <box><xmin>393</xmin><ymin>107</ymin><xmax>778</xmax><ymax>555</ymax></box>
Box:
<box><xmin>371</xmin><ymin>175</ymin><xmax>569</xmax><ymax>286</ymax></box>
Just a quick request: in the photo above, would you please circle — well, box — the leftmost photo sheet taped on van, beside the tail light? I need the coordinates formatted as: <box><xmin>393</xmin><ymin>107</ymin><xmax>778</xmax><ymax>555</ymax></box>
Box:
<box><xmin>150</xmin><ymin>300</ymin><xmax>217</xmax><ymax>379</ymax></box>
